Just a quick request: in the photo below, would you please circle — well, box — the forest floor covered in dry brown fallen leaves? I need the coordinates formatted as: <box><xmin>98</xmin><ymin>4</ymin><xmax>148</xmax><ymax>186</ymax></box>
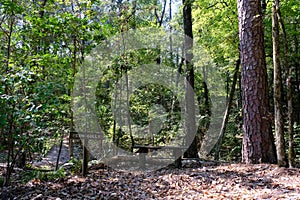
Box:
<box><xmin>0</xmin><ymin>162</ymin><xmax>300</xmax><ymax>200</ymax></box>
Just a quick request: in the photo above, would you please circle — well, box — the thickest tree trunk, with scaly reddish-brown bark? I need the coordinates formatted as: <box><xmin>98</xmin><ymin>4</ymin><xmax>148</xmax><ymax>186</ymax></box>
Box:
<box><xmin>238</xmin><ymin>0</ymin><xmax>276</xmax><ymax>163</ymax></box>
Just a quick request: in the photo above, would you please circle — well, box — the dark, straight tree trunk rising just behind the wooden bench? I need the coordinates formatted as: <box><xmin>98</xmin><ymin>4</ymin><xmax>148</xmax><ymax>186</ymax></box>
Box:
<box><xmin>182</xmin><ymin>0</ymin><xmax>199</xmax><ymax>158</ymax></box>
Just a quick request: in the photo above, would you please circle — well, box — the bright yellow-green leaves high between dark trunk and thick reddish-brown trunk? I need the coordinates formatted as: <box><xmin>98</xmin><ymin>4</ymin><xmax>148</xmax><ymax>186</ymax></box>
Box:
<box><xmin>193</xmin><ymin>0</ymin><xmax>239</xmax><ymax>69</ymax></box>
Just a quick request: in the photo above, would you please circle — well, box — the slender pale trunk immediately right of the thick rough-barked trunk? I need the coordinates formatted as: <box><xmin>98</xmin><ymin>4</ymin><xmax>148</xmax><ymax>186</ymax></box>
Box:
<box><xmin>272</xmin><ymin>0</ymin><xmax>286</xmax><ymax>167</ymax></box>
